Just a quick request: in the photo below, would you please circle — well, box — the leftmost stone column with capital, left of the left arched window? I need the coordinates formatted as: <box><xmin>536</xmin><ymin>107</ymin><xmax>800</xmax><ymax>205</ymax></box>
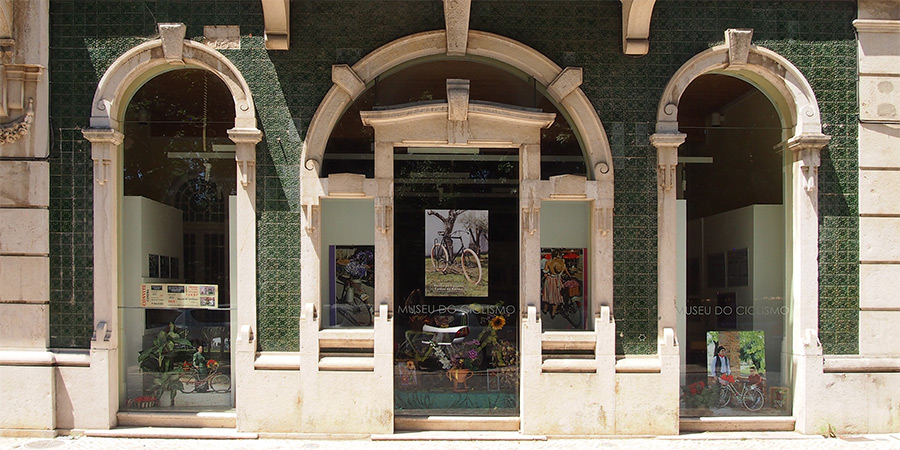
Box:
<box><xmin>82</xmin><ymin>128</ymin><xmax>125</xmax><ymax>428</ymax></box>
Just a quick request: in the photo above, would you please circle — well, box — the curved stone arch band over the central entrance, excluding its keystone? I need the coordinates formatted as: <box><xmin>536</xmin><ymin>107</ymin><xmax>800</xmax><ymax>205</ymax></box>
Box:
<box><xmin>303</xmin><ymin>30</ymin><xmax>612</xmax><ymax>182</ymax></box>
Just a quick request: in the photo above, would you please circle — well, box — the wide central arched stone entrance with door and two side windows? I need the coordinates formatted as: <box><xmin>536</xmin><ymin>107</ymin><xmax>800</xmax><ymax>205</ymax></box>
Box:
<box><xmin>300</xmin><ymin>32</ymin><xmax>615</xmax><ymax>434</ymax></box>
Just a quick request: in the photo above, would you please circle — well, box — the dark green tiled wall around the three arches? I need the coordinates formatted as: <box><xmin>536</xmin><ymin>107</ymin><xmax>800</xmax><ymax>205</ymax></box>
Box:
<box><xmin>50</xmin><ymin>0</ymin><xmax>859</xmax><ymax>353</ymax></box>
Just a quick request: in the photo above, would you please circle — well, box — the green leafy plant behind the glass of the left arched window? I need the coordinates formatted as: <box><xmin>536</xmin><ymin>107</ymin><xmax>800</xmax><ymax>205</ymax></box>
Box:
<box><xmin>138</xmin><ymin>323</ymin><xmax>191</xmax><ymax>405</ymax></box>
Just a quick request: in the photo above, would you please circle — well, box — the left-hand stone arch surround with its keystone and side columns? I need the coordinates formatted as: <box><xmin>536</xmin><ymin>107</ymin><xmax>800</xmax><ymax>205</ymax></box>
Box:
<box><xmin>82</xmin><ymin>24</ymin><xmax>262</xmax><ymax>427</ymax></box>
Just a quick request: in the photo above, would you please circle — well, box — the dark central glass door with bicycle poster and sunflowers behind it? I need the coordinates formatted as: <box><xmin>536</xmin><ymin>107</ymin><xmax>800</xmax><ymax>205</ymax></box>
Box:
<box><xmin>394</xmin><ymin>148</ymin><xmax>520</xmax><ymax>416</ymax></box>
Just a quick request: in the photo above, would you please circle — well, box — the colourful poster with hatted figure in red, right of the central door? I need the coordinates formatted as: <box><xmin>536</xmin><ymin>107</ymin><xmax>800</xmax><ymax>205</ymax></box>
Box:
<box><xmin>541</xmin><ymin>248</ymin><xmax>589</xmax><ymax>330</ymax></box>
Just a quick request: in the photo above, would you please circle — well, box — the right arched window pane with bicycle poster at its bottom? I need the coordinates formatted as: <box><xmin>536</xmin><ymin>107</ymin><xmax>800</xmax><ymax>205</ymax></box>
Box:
<box><xmin>677</xmin><ymin>75</ymin><xmax>791</xmax><ymax>416</ymax></box>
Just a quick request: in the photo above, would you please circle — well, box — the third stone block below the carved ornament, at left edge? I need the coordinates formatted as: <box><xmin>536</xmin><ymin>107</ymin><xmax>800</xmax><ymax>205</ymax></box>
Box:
<box><xmin>0</xmin><ymin>256</ymin><xmax>50</xmax><ymax>302</ymax></box>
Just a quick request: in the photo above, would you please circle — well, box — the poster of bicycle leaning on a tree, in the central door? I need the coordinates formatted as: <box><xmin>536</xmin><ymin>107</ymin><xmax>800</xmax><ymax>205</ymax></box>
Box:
<box><xmin>424</xmin><ymin>209</ymin><xmax>489</xmax><ymax>297</ymax></box>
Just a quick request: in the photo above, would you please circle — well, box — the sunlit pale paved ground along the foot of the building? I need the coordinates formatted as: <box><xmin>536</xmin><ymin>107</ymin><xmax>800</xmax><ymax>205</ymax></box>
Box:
<box><xmin>0</xmin><ymin>433</ymin><xmax>900</xmax><ymax>450</ymax></box>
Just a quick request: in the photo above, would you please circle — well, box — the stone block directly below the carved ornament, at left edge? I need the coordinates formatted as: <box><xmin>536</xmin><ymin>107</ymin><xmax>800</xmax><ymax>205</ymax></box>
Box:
<box><xmin>0</xmin><ymin>161</ymin><xmax>50</xmax><ymax>207</ymax></box>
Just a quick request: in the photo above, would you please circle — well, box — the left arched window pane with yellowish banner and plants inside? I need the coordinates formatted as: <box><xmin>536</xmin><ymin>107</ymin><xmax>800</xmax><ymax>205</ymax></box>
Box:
<box><xmin>120</xmin><ymin>69</ymin><xmax>236</xmax><ymax>411</ymax></box>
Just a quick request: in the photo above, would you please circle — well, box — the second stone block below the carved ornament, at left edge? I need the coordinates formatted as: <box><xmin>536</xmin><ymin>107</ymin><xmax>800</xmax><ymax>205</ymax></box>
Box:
<box><xmin>0</xmin><ymin>208</ymin><xmax>50</xmax><ymax>255</ymax></box>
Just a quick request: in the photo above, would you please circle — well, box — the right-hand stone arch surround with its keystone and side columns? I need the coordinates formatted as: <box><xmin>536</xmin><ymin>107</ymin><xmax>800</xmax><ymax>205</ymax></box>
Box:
<box><xmin>650</xmin><ymin>29</ymin><xmax>831</xmax><ymax>415</ymax></box>
